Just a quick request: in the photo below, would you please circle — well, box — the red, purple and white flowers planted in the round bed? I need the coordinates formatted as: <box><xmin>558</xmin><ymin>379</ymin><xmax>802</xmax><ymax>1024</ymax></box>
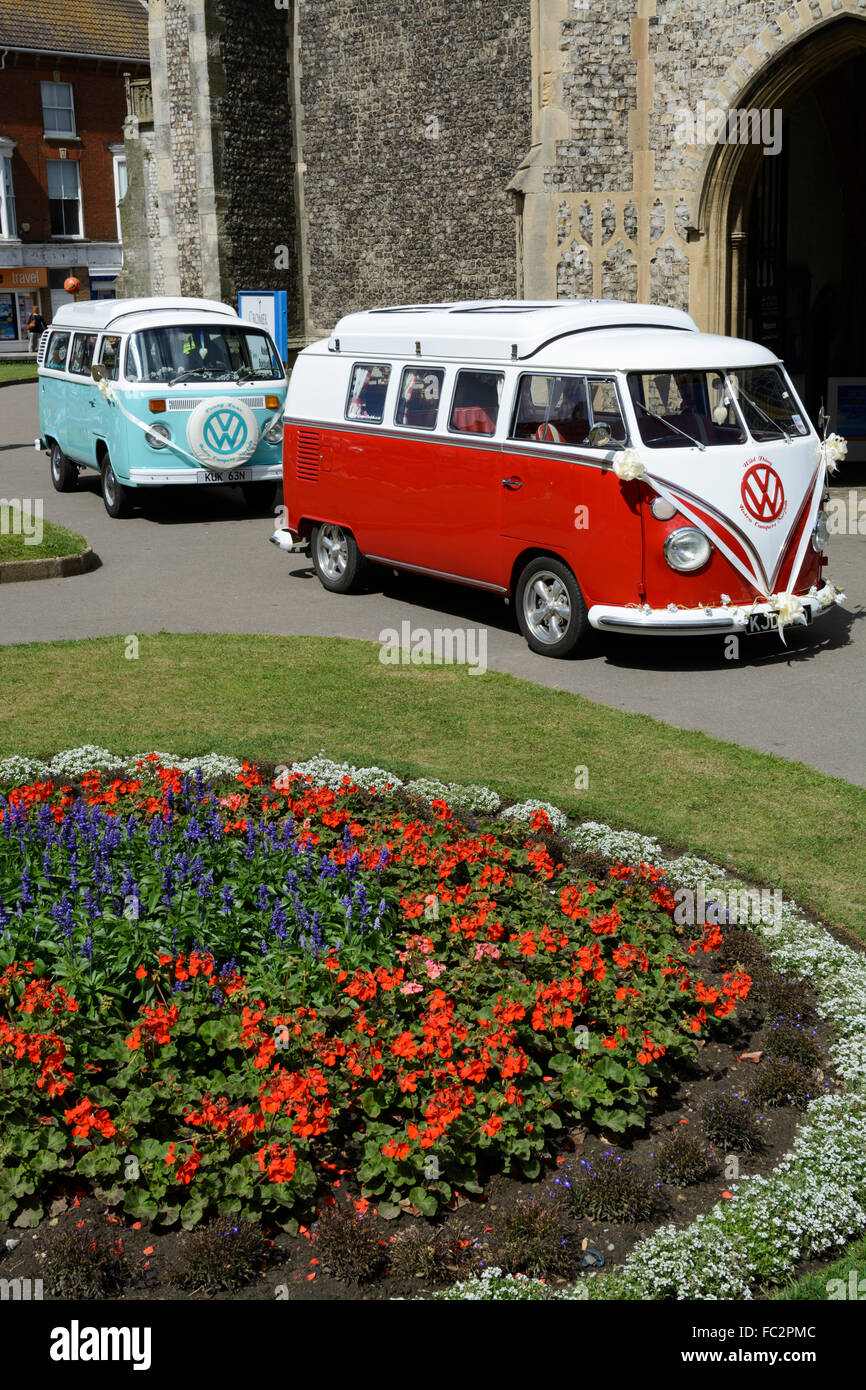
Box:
<box><xmin>0</xmin><ymin>749</ymin><xmax>866</xmax><ymax>1297</ymax></box>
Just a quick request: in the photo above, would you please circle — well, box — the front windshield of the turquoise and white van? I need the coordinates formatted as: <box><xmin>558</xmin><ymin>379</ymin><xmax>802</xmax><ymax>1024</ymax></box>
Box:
<box><xmin>126</xmin><ymin>324</ymin><xmax>284</xmax><ymax>386</ymax></box>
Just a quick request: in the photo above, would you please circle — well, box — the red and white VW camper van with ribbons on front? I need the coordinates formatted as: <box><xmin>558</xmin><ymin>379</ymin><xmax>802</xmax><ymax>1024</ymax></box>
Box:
<box><xmin>271</xmin><ymin>300</ymin><xmax>837</xmax><ymax>656</ymax></box>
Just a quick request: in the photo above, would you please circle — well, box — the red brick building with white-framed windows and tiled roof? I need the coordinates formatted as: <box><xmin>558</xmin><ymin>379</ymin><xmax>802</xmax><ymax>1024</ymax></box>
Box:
<box><xmin>0</xmin><ymin>0</ymin><xmax>149</xmax><ymax>350</ymax></box>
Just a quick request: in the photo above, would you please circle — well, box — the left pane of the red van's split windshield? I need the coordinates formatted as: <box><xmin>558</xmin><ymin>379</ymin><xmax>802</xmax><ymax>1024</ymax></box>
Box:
<box><xmin>628</xmin><ymin>370</ymin><xmax>745</xmax><ymax>449</ymax></box>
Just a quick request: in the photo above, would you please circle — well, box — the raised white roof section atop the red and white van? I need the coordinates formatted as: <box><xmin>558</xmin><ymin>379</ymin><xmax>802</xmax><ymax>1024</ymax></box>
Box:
<box><xmin>328</xmin><ymin>299</ymin><xmax>698</xmax><ymax>361</ymax></box>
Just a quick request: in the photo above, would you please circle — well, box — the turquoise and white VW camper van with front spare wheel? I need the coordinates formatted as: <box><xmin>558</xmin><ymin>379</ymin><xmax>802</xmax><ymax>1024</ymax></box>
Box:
<box><xmin>38</xmin><ymin>299</ymin><xmax>286</xmax><ymax>517</ymax></box>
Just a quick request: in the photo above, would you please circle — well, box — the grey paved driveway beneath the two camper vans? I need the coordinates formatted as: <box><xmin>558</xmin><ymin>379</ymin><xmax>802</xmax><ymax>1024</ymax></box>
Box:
<box><xmin>0</xmin><ymin>386</ymin><xmax>866</xmax><ymax>783</ymax></box>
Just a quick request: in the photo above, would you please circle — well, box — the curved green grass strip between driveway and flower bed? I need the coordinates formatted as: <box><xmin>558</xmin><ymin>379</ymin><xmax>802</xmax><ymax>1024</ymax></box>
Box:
<box><xmin>0</xmin><ymin>634</ymin><xmax>866</xmax><ymax>941</ymax></box>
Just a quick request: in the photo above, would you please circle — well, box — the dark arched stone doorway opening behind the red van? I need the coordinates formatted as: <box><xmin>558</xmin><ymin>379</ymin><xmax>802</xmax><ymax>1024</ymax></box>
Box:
<box><xmin>692</xmin><ymin>13</ymin><xmax>866</xmax><ymax>417</ymax></box>
